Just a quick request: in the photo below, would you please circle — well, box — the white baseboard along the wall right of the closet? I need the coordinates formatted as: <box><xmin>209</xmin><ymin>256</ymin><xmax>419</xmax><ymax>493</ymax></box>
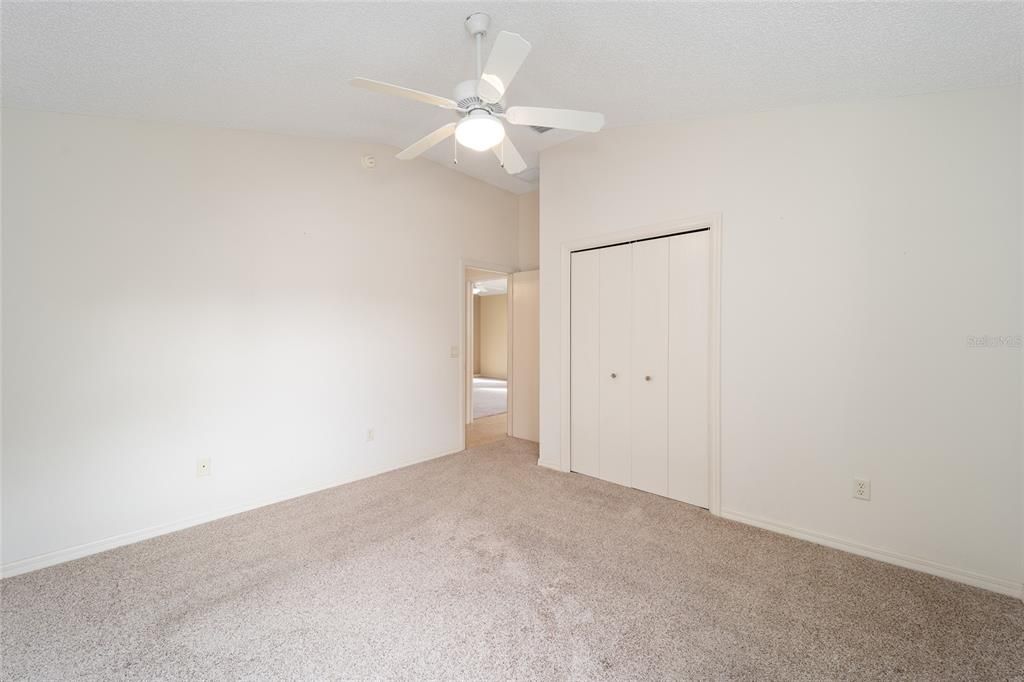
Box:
<box><xmin>722</xmin><ymin>509</ymin><xmax>1024</xmax><ymax>599</ymax></box>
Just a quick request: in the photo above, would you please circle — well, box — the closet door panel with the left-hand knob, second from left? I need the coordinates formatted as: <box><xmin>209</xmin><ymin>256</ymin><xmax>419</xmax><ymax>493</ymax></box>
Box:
<box><xmin>596</xmin><ymin>244</ymin><xmax>633</xmax><ymax>485</ymax></box>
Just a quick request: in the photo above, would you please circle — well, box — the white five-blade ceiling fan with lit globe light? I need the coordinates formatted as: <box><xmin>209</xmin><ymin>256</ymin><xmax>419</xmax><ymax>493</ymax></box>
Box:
<box><xmin>351</xmin><ymin>12</ymin><xmax>604</xmax><ymax>174</ymax></box>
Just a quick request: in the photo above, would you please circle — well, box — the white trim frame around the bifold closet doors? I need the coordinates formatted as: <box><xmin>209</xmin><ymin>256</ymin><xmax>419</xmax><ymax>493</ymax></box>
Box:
<box><xmin>561</xmin><ymin>213</ymin><xmax>722</xmax><ymax>516</ymax></box>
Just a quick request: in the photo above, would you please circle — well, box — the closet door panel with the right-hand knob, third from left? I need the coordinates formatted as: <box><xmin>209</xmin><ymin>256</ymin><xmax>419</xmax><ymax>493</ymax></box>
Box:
<box><xmin>631</xmin><ymin>240</ymin><xmax>669</xmax><ymax>496</ymax></box>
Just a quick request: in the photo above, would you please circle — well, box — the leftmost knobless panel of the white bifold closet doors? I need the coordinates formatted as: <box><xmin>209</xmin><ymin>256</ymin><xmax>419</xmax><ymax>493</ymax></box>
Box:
<box><xmin>569</xmin><ymin>251</ymin><xmax>600</xmax><ymax>476</ymax></box>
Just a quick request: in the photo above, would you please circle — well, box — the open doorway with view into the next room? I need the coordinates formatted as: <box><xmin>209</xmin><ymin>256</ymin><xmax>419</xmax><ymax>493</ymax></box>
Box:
<box><xmin>466</xmin><ymin>268</ymin><xmax>510</xmax><ymax>447</ymax></box>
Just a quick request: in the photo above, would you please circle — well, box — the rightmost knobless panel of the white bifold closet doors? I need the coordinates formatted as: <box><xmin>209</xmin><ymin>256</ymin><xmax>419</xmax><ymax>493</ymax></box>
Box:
<box><xmin>669</xmin><ymin>231</ymin><xmax>711</xmax><ymax>507</ymax></box>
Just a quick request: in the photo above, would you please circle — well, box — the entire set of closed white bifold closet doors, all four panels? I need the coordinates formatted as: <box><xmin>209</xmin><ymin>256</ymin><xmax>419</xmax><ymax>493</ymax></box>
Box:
<box><xmin>569</xmin><ymin>231</ymin><xmax>711</xmax><ymax>507</ymax></box>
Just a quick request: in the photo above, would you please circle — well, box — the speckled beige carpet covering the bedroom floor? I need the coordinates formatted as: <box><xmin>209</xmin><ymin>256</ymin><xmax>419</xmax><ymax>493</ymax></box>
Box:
<box><xmin>0</xmin><ymin>439</ymin><xmax>1024</xmax><ymax>680</ymax></box>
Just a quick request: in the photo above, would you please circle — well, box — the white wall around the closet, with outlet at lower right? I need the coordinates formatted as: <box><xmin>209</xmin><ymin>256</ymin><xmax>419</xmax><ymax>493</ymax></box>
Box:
<box><xmin>541</xmin><ymin>88</ymin><xmax>1024</xmax><ymax>592</ymax></box>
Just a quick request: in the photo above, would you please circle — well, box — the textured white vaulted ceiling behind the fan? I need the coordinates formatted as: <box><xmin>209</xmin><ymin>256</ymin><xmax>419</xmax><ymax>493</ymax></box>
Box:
<box><xmin>2</xmin><ymin>1</ymin><xmax>1024</xmax><ymax>191</ymax></box>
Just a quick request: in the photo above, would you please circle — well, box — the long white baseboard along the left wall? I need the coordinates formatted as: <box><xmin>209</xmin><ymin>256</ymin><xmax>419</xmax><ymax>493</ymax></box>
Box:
<box><xmin>0</xmin><ymin>450</ymin><xmax>462</xmax><ymax>578</ymax></box>
